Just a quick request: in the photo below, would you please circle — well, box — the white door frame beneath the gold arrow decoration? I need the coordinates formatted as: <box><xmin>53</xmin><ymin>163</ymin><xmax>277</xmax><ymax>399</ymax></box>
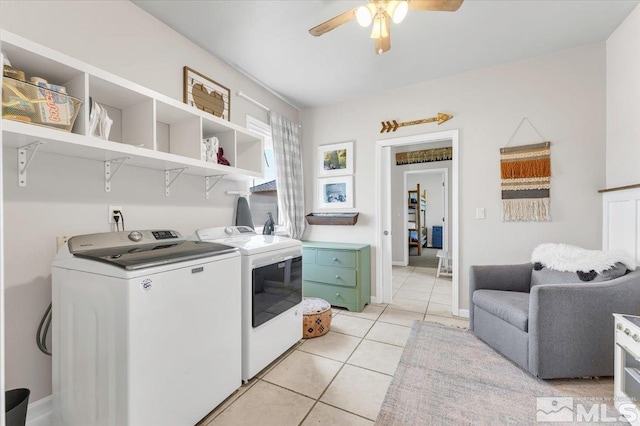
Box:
<box><xmin>375</xmin><ymin>129</ymin><xmax>460</xmax><ymax>315</ymax></box>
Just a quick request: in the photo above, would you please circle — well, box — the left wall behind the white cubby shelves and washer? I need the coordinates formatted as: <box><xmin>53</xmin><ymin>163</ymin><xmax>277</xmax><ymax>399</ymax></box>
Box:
<box><xmin>0</xmin><ymin>1</ymin><xmax>298</xmax><ymax>401</ymax></box>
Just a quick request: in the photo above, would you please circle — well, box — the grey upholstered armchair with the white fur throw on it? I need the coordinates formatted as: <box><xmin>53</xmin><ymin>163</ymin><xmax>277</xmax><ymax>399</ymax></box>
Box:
<box><xmin>469</xmin><ymin>263</ymin><xmax>640</xmax><ymax>379</ymax></box>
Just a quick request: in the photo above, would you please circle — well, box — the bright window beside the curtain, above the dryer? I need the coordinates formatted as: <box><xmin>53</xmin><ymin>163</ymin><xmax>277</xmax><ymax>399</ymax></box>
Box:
<box><xmin>247</xmin><ymin>115</ymin><xmax>278</xmax><ymax>233</ymax></box>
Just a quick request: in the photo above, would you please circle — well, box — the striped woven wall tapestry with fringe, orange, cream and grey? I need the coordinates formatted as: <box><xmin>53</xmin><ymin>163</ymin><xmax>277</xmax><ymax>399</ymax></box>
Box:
<box><xmin>500</xmin><ymin>142</ymin><xmax>551</xmax><ymax>222</ymax></box>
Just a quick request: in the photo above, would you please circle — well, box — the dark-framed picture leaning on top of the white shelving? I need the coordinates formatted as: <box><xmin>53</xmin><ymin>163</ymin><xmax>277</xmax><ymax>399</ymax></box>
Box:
<box><xmin>182</xmin><ymin>67</ymin><xmax>231</xmax><ymax>120</ymax></box>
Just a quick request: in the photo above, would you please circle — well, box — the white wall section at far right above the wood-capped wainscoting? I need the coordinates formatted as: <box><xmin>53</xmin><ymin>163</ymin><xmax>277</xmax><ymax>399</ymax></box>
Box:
<box><xmin>606</xmin><ymin>6</ymin><xmax>640</xmax><ymax>188</ymax></box>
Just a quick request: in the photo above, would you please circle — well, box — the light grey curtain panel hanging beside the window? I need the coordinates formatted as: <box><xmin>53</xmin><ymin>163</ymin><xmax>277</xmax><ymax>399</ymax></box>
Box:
<box><xmin>269</xmin><ymin>111</ymin><xmax>305</xmax><ymax>240</ymax></box>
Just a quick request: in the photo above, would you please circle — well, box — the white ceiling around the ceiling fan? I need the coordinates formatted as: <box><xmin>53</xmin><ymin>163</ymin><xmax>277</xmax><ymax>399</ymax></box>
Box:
<box><xmin>133</xmin><ymin>0</ymin><xmax>640</xmax><ymax>108</ymax></box>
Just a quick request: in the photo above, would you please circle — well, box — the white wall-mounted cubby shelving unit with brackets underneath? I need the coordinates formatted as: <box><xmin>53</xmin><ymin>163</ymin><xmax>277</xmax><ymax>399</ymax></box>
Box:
<box><xmin>0</xmin><ymin>30</ymin><xmax>263</xmax><ymax>197</ymax></box>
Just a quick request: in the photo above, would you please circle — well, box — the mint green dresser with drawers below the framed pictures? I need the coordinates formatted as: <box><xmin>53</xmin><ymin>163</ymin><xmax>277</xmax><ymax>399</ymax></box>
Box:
<box><xmin>302</xmin><ymin>241</ymin><xmax>371</xmax><ymax>312</ymax></box>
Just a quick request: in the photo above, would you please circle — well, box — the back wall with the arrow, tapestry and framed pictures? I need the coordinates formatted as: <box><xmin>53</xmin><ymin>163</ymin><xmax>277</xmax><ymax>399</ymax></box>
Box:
<box><xmin>302</xmin><ymin>43</ymin><xmax>605</xmax><ymax>309</ymax></box>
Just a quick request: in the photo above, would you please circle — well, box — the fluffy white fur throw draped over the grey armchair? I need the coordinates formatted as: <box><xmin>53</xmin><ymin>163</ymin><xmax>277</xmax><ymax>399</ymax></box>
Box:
<box><xmin>531</xmin><ymin>243</ymin><xmax>636</xmax><ymax>274</ymax></box>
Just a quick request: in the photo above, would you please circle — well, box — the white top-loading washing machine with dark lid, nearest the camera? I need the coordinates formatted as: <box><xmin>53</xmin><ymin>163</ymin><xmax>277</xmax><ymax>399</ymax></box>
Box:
<box><xmin>52</xmin><ymin>230</ymin><xmax>242</xmax><ymax>426</ymax></box>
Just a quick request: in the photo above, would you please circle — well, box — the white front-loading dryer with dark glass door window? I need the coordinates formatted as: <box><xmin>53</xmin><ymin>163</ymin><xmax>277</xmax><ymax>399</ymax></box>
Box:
<box><xmin>196</xmin><ymin>226</ymin><xmax>302</xmax><ymax>382</ymax></box>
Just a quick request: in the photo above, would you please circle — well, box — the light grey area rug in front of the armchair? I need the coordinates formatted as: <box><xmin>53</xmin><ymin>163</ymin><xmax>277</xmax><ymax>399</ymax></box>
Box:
<box><xmin>376</xmin><ymin>321</ymin><xmax>627</xmax><ymax>425</ymax></box>
